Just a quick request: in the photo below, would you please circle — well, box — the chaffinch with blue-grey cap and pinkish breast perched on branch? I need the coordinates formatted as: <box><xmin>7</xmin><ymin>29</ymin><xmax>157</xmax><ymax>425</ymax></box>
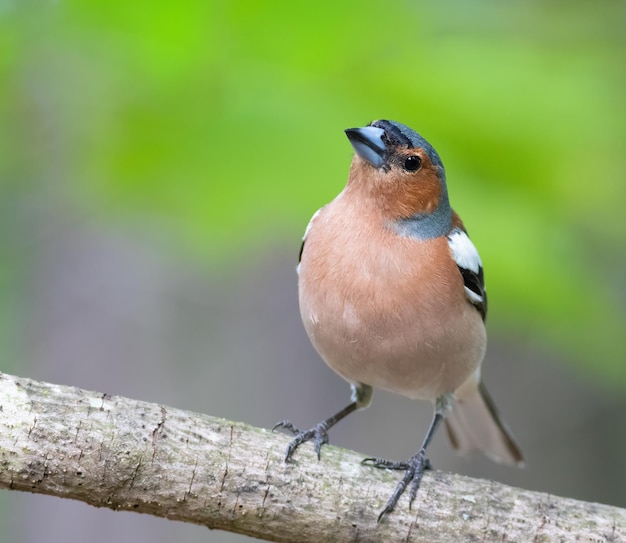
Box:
<box><xmin>274</xmin><ymin>120</ymin><xmax>524</xmax><ymax>522</ymax></box>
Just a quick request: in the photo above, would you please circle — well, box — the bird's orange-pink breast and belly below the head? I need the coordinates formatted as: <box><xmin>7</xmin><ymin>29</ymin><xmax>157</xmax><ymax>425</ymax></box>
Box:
<box><xmin>299</xmin><ymin>195</ymin><xmax>486</xmax><ymax>399</ymax></box>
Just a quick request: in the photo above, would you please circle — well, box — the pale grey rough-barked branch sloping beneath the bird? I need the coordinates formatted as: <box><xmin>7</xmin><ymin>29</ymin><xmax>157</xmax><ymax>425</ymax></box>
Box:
<box><xmin>0</xmin><ymin>373</ymin><xmax>626</xmax><ymax>543</ymax></box>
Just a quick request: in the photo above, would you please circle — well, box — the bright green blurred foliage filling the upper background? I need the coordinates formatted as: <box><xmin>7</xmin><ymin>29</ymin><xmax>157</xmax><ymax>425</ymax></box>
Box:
<box><xmin>0</xmin><ymin>0</ymin><xmax>626</xmax><ymax>386</ymax></box>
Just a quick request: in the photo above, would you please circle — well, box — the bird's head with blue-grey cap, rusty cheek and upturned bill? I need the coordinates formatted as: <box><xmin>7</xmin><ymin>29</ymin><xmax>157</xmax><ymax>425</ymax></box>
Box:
<box><xmin>346</xmin><ymin>120</ymin><xmax>452</xmax><ymax>239</ymax></box>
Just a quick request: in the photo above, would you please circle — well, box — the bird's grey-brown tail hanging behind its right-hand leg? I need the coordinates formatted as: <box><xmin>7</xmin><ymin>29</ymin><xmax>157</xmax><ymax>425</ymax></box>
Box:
<box><xmin>446</xmin><ymin>381</ymin><xmax>524</xmax><ymax>466</ymax></box>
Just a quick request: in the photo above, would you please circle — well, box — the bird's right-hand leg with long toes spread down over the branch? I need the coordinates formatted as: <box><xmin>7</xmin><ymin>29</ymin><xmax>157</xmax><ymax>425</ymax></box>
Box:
<box><xmin>362</xmin><ymin>396</ymin><xmax>453</xmax><ymax>522</ymax></box>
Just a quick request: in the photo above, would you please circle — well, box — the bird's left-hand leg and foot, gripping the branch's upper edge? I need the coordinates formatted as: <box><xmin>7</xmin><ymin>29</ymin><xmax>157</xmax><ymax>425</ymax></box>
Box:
<box><xmin>273</xmin><ymin>383</ymin><xmax>372</xmax><ymax>462</ymax></box>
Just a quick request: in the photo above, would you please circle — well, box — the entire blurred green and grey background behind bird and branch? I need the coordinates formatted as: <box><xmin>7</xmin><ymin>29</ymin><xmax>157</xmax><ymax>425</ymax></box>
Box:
<box><xmin>0</xmin><ymin>0</ymin><xmax>626</xmax><ymax>543</ymax></box>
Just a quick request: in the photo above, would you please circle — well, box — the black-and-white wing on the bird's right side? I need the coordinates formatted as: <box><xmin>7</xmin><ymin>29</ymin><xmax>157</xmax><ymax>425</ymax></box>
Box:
<box><xmin>448</xmin><ymin>226</ymin><xmax>487</xmax><ymax>320</ymax></box>
